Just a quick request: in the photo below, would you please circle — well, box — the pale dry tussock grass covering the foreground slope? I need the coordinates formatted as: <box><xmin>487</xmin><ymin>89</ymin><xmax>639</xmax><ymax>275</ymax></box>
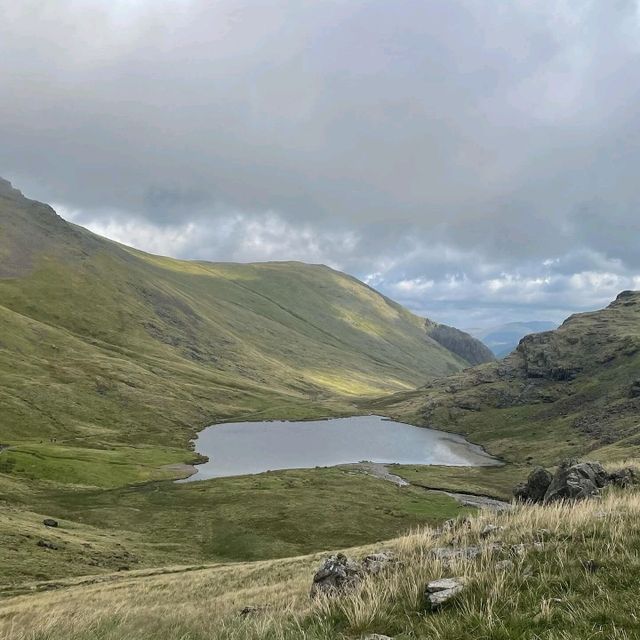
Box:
<box><xmin>5</xmin><ymin>491</ymin><xmax>640</xmax><ymax>640</ymax></box>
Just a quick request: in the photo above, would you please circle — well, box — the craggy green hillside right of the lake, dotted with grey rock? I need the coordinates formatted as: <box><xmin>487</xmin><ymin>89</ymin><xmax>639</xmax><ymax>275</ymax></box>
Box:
<box><xmin>372</xmin><ymin>291</ymin><xmax>640</xmax><ymax>464</ymax></box>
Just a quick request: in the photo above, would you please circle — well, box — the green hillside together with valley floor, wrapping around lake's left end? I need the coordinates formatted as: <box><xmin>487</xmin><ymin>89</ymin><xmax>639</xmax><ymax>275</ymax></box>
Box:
<box><xmin>0</xmin><ymin>176</ymin><xmax>498</xmax><ymax>588</ymax></box>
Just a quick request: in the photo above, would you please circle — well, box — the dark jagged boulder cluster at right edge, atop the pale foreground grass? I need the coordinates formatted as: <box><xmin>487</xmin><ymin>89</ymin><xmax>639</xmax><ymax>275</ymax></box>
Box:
<box><xmin>514</xmin><ymin>460</ymin><xmax>635</xmax><ymax>504</ymax></box>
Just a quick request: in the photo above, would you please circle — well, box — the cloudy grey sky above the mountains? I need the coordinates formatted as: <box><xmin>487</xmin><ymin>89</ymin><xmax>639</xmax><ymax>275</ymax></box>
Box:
<box><xmin>0</xmin><ymin>0</ymin><xmax>640</xmax><ymax>328</ymax></box>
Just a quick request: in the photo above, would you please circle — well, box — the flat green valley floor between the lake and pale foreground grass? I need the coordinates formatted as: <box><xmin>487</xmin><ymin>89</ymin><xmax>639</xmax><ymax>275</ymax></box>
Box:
<box><xmin>0</xmin><ymin>466</ymin><xmax>526</xmax><ymax>595</ymax></box>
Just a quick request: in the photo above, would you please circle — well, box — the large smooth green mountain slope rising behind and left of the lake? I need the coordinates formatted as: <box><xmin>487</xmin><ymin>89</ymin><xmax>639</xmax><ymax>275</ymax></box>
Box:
<box><xmin>0</xmin><ymin>181</ymin><xmax>476</xmax><ymax>460</ymax></box>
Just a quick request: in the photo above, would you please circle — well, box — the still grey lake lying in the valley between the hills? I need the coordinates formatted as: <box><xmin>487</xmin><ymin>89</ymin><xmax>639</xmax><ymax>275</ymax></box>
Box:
<box><xmin>182</xmin><ymin>416</ymin><xmax>500</xmax><ymax>482</ymax></box>
